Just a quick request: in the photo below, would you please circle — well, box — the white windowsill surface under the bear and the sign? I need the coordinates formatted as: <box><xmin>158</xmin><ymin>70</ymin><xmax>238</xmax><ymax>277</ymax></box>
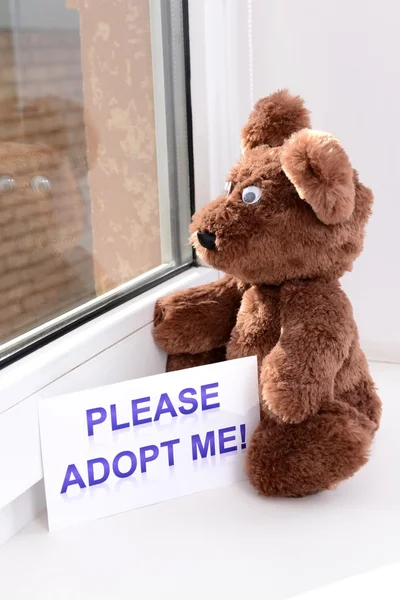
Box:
<box><xmin>0</xmin><ymin>363</ymin><xmax>400</xmax><ymax>600</ymax></box>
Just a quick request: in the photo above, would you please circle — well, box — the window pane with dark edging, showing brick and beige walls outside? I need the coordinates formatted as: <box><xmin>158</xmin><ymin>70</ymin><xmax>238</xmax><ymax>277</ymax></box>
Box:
<box><xmin>0</xmin><ymin>0</ymin><xmax>192</xmax><ymax>364</ymax></box>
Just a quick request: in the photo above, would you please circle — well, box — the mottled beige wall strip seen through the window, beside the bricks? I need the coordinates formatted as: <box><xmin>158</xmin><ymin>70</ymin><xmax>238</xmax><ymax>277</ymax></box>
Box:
<box><xmin>80</xmin><ymin>0</ymin><xmax>161</xmax><ymax>293</ymax></box>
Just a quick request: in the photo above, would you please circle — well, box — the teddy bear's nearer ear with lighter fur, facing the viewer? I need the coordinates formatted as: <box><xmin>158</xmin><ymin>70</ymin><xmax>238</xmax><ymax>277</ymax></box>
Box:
<box><xmin>281</xmin><ymin>129</ymin><xmax>355</xmax><ymax>225</ymax></box>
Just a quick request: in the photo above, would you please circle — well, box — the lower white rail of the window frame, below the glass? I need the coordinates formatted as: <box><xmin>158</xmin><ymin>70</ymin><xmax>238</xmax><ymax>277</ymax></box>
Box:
<box><xmin>0</xmin><ymin>267</ymin><xmax>219</xmax><ymax>509</ymax></box>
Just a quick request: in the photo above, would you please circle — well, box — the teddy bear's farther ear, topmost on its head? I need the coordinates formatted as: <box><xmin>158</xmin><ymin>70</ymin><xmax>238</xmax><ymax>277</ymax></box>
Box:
<box><xmin>241</xmin><ymin>90</ymin><xmax>311</xmax><ymax>152</ymax></box>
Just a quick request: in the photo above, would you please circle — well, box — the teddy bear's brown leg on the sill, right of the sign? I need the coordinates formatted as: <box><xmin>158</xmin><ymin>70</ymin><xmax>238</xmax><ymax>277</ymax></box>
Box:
<box><xmin>246</xmin><ymin>411</ymin><xmax>373</xmax><ymax>497</ymax></box>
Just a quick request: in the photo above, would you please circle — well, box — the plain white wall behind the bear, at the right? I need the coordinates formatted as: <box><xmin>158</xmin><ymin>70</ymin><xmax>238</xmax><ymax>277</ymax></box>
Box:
<box><xmin>253</xmin><ymin>0</ymin><xmax>400</xmax><ymax>362</ymax></box>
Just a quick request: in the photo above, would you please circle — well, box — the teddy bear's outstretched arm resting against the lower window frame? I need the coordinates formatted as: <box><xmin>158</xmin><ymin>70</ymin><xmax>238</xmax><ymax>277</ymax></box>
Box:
<box><xmin>153</xmin><ymin>276</ymin><xmax>243</xmax><ymax>354</ymax></box>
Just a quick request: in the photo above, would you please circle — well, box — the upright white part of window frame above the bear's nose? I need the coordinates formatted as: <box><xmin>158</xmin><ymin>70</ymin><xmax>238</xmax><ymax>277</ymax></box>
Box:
<box><xmin>189</xmin><ymin>0</ymin><xmax>251</xmax><ymax>209</ymax></box>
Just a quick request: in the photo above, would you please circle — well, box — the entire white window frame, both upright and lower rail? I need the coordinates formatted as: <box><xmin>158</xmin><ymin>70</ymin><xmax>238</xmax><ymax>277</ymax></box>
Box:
<box><xmin>0</xmin><ymin>0</ymin><xmax>252</xmax><ymax>544</ymax></box>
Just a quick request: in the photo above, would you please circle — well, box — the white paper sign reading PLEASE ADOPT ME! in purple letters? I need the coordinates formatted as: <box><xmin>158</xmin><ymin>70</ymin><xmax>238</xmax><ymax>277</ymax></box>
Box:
<box><xmin>39</xmin><ymin>357</ymin><xmax>259</xmax><ymax>530</ymax></box>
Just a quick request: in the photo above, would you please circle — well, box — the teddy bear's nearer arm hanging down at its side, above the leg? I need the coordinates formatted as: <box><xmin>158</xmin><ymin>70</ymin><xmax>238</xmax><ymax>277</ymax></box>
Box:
<box><xmin>260</xmin><ymin>282</ymin><xmax>355</xmax><ymax>423</ymax></box>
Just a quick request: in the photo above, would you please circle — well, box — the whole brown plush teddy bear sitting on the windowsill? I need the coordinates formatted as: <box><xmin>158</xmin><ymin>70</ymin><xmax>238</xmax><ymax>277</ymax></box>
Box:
<box><xmin>154</xmin><ymin>91</ymin><xmax>381</xmax><ymax>496</ymax></box>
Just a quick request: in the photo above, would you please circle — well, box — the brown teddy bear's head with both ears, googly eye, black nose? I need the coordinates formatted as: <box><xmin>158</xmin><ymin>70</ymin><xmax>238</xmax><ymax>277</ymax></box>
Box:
<box><xmin>191</xmin><ymin>90</ymin><xmax>372</xmax><ymax>285</ymax></box>
